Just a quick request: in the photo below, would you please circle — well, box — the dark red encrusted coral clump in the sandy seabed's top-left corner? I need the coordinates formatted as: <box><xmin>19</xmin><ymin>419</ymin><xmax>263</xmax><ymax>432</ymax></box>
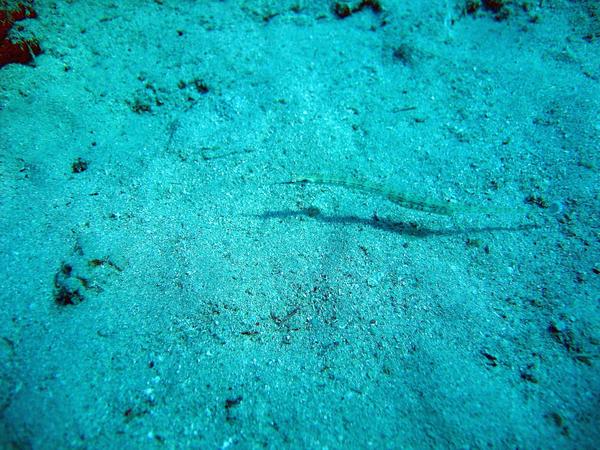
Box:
<box><xmin>0</xmin><ymin>2</ymin><xmax>42</xmax><ymax>67</ymax></box>
